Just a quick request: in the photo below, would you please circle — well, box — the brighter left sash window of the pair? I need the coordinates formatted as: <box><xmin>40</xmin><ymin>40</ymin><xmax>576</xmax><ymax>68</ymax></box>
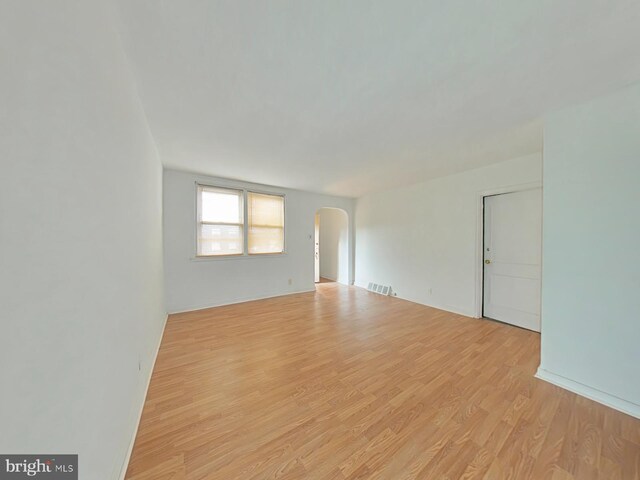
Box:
<box><xmin>197</xmin><ymin>185</ymin><xmax>244</xmax><ymax>256</ymax></box>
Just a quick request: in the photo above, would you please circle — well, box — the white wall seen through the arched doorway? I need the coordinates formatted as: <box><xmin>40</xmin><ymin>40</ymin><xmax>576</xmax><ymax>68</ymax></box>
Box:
<box><xmin>318</xmin><ymin>208</ymin><xmax>349</xmax><ymax>284</ymax></box>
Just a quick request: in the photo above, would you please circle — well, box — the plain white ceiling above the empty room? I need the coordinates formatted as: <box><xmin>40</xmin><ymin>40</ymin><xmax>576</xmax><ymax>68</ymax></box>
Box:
<box><xmin>120</xmin><ymin>0</ymin><xmax>640</xmax><ymax>197</ymax></box>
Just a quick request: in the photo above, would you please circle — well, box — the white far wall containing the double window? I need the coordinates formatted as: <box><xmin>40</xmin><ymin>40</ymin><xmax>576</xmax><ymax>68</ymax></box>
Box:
<box><xmin>164</xmin><ymin>170</ymin><xmax>354</xmax><ymax>312</ymax></box>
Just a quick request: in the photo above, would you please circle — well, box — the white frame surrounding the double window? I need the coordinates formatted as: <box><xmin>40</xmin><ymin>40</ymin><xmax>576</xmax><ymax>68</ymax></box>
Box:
<box><xmin>194</xmin><ymin>182</ymin><xmax>287</xmax><ymax>261</ymax></box>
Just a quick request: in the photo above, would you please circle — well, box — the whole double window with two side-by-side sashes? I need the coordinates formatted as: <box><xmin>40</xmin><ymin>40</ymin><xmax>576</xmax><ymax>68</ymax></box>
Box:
<box><xmin>197</xmin><ymin>185</ymin><xmax>284</xmax><ymax>257</ymax></box>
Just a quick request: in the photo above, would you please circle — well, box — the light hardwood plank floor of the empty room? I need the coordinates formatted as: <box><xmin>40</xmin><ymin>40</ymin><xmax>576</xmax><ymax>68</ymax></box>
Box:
<box><xmin>127</xmin><ymin>283</ymin><xmax>640</xmax><ymax>480</ymax></box>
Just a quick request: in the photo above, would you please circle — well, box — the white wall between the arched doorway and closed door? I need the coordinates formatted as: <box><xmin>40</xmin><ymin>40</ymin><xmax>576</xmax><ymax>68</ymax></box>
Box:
<box><xmin>356</xmin><ymin>154</ymin><xmax>542</xmax><ymax>316</ymax></box>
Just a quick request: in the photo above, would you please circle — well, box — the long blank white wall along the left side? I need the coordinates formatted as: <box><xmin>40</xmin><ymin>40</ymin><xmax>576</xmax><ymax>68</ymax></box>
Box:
<box><xmin>0</xmin><ymin>0</ymin><xmax>166</xmax><ymax>480</ymax></box>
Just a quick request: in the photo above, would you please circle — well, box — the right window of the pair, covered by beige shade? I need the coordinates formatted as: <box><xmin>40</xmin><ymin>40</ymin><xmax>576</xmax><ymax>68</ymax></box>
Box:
<box><xmin>247</xmin><ymin>192</ymin><xmax>284</xmax><ymax>255</ymax></box>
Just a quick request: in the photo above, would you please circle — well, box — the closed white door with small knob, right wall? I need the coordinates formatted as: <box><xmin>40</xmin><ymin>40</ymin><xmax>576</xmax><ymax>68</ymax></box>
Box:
<box><xmin>483</xmin><ymin>188</ymin><xmax>542</xmax><ymax>332</ymax></box>
